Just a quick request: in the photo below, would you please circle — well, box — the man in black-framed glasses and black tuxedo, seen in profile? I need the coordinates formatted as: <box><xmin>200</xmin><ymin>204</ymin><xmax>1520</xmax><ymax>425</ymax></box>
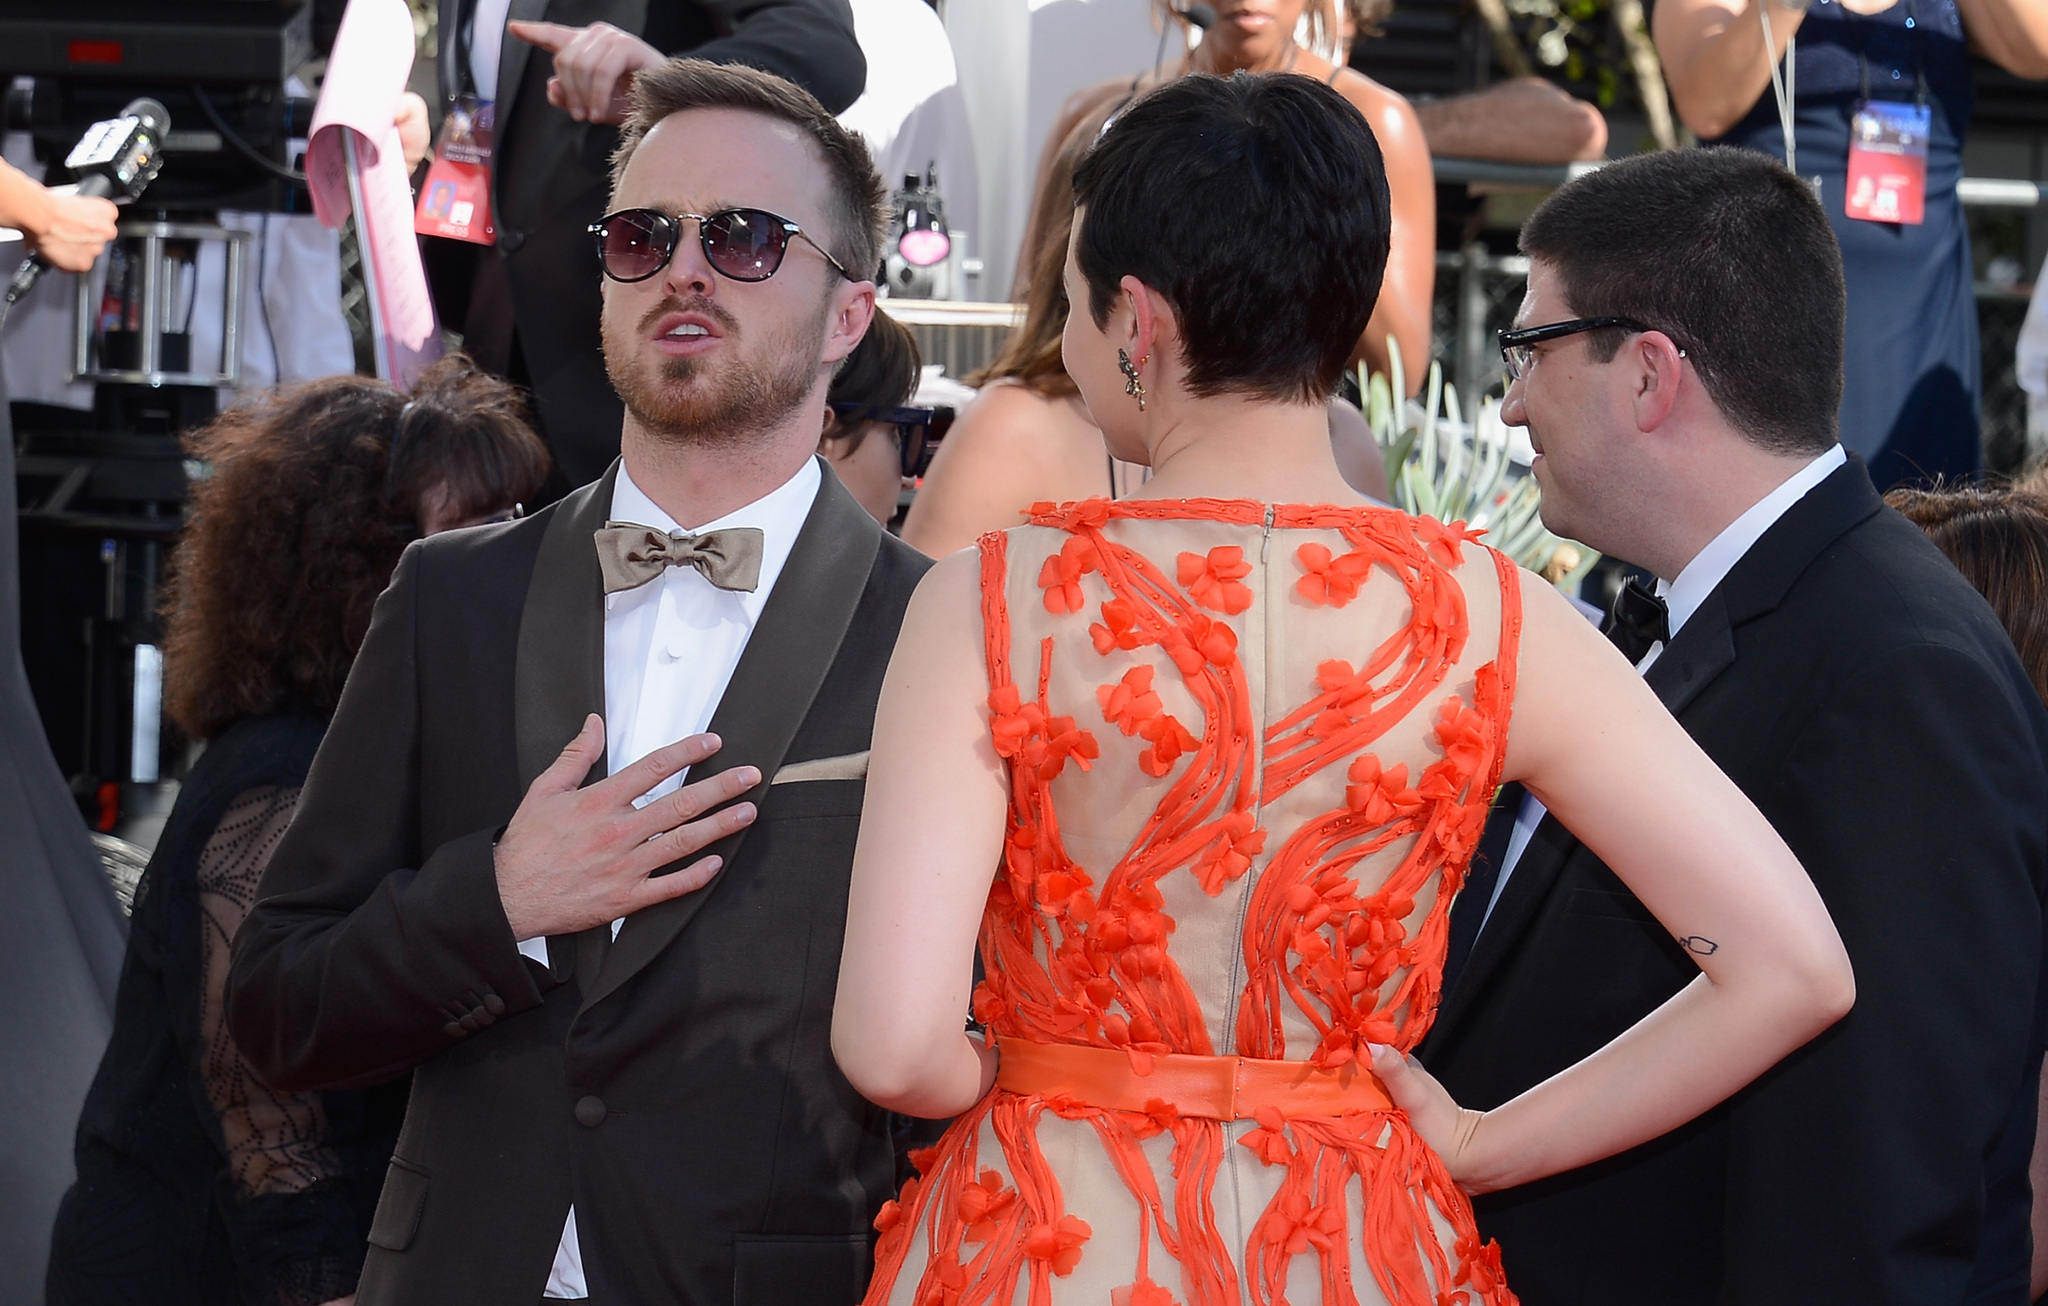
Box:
<box><xmin>1417</xmin><ymin>149</ymin><xmax>2048</xmax><ymax>1306</ymax></box>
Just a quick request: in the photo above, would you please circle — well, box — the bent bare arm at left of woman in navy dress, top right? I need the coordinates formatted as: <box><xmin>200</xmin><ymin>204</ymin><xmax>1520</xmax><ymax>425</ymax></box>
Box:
<box><xmin>1651</xmin><ymin>0</ymin><xmax>1806</xmax><ymax>139</ymax></box>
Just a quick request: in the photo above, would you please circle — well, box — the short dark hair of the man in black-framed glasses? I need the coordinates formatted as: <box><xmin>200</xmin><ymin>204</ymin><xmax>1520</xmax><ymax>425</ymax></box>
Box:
<box><xmin>1522</xmin><ymin>147</ymin><xmax>1847</xmax><ymax>454</ymax></box>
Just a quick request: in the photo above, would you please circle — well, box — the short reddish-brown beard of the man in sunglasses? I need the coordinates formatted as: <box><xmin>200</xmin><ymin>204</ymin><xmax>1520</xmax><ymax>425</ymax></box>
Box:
<box><xmin>602</xmin><ymin>299</ymin><xmax>827</xmax><ymax>446</ymax></box>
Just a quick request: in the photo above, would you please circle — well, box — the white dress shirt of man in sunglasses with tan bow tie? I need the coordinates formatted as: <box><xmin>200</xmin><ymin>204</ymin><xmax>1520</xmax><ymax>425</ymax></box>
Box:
<box><xmin>518</xmin><ymin>459</ymin><xmax>823</xmax><ymax>1298</ymax></box>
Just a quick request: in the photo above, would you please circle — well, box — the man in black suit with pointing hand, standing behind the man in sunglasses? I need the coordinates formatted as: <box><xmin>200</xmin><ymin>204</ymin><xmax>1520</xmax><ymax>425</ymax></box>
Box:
<box><xmin>426</xmin><ymin>0</ymin><xmax>872</xmax><ymax>499</ymax></box>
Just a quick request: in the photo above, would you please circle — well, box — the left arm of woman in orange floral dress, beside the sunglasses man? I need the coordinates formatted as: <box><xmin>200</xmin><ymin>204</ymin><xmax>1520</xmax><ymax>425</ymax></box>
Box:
<box><xmin>831</xmin><ymin>553</ymin><xmax>1010</xmax><ymax>1120</ymax></box>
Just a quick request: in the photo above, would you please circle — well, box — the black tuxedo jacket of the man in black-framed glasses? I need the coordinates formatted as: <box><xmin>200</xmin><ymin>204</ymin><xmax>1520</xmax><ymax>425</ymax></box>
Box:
<box><xmin>1419</xmin><ymin>456</ymin><xmax>2048</xmax><ymax>1306</ymax></box>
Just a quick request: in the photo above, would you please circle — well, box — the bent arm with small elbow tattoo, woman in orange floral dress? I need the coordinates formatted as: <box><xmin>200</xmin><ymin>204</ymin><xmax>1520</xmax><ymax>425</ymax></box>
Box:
<box><xmin>1374</xmin><ymin>579</ymin><xmax>1855</xmax><ymax>1191</ymax></box>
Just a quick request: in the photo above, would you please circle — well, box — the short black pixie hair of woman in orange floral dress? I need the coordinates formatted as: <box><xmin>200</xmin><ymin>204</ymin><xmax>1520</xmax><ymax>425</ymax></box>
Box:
<box><xmin>1073</xmin><ymin>72</ymin><xmax>1393</xmax><ymax>403</ymax></box>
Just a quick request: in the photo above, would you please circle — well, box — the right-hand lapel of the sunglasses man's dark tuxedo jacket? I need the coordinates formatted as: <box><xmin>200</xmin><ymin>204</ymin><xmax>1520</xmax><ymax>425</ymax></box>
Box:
<box><xmin>584</xmin><ymin>463</ymin><xmax>883</xmax><ymax>1009</ymax></box>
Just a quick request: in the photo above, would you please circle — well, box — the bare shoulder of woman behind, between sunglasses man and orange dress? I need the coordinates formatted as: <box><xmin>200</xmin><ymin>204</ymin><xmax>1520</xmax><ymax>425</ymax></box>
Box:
<box><xmin>903</xmin><ymin>383</ymin><xmax>1110</xmax><ymax>557</ymax></box>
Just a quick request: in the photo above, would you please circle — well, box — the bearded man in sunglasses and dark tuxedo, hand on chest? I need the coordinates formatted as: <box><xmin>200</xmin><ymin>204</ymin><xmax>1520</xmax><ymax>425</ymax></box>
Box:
<box><xmin>229</xmin><ymin>59</ymin><xmax>926</xmax><ymax>1306</ymax></box>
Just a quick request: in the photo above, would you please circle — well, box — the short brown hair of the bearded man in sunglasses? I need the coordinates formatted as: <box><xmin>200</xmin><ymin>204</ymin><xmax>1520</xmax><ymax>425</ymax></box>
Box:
<box><xmin>612</xmin><ymin>59</ymin><xmax>889</xmax><ymax>278</ymax></box>
